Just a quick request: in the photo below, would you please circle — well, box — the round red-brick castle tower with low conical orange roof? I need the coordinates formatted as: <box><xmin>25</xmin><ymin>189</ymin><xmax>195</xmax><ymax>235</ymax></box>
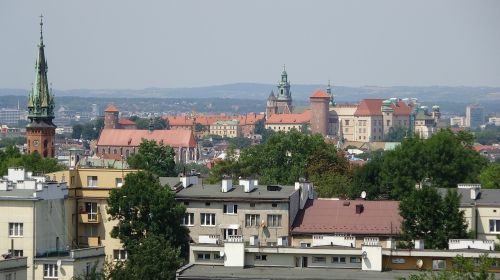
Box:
<box><xmin>309</xmin><ymin>90</ymin><xmax>330</xmax><ymax>136</ymax></box>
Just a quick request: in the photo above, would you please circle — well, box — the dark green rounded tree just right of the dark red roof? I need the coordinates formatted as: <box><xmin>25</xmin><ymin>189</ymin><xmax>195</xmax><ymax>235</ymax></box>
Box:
<box><xmin>399</xmin><ymin>185</ymin><xmax>467</xmax><ymax>249</ymax></box>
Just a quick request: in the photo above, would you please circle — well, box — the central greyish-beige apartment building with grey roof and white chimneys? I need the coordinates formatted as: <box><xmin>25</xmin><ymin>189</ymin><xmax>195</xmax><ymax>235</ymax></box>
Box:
<box><xmin>176</xmin><ymin>177</ymin><xmax>312</xmax><ymax>246</ymax></box>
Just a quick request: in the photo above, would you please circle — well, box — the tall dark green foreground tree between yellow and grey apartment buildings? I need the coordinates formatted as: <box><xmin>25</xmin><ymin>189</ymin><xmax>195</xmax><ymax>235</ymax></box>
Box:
<box><xmin>108</xmin><ymin>171</ymin><xmax>189</xmax><ymax>279</ymax></box>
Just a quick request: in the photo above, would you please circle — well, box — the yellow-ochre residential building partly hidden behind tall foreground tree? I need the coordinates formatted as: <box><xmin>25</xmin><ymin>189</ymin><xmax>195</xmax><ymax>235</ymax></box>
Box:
<box><xmin>48</xmin><ymin>163</ymin><xmax>137</xmax><ymax>260</ymax></box>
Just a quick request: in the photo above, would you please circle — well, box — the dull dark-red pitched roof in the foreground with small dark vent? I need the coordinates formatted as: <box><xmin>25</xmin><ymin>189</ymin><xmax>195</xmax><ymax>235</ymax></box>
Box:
<box><xmin>292</xmin><ymin>199</ymin><xmax>403</xmax><ymax>235</ymax></box>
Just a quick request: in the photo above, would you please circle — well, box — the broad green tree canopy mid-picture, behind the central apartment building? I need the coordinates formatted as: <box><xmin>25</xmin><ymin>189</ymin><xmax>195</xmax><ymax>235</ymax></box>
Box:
<box><xmin>209</xmin><ymin>130</ymin><xmax>351</xmax><ymax>196</ymax></box>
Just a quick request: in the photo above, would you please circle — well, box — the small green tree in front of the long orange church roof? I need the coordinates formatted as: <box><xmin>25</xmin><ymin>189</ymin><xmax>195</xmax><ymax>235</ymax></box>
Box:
<box><xmin>127</xmin><ymin>139</ymin><xmax>176</xmax><ymax>176</ymax></box>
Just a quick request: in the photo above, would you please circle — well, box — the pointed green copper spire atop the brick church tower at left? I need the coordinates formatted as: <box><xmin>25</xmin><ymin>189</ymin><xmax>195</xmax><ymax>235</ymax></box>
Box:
<box><xmin>28</xmin><ymin>15</ymin><xmax>54</xmax><ymax>121</ymax></box>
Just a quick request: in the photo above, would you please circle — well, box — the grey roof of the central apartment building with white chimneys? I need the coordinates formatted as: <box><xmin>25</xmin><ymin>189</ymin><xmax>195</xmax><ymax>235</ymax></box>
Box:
<box><xmin>176</xmin><ymin>185</ymin><xmax>296</xmax><ymax>201</ymax></box>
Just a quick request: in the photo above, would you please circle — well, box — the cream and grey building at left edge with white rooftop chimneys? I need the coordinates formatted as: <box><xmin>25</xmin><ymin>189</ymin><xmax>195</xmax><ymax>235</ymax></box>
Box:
<box><xmin>0</xmin><ymin>168</ymin><xmax>71</xmax><ymax>279</ymax></box>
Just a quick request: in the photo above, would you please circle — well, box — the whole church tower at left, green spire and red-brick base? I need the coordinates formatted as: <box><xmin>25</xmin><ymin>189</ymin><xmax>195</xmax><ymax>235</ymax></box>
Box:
<box><xmin>26</xmin><ymin>16</ymin><xmax>56</xmax><ymax>158</ymax></box>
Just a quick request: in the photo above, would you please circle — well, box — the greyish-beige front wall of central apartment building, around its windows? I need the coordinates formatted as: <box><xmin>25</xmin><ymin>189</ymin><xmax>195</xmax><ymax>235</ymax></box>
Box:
<box><xmin>185</xmin><ymin>201</ymin><xmax>290</xmax><ymax>244</ymax></box>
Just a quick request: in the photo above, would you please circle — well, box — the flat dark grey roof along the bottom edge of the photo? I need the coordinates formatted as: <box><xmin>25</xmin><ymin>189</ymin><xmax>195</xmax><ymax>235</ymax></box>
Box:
<box><xmin>177</xmin><ymin>264</ymin><xmax>432</xmax><ymax>280</ymax></box>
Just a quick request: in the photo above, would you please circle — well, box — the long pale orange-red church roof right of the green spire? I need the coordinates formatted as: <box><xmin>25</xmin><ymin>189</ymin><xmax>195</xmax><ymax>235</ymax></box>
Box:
<box><xmin>97</xmin><ymin>128</ymin><xmax>196</xmax><ymax>148</ymax></box>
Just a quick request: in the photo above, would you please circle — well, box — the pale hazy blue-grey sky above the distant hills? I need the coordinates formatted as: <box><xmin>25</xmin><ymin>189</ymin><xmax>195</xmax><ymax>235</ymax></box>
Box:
<box><xmin>0</xmin><ymin>0</ymin><xmax>500</xmax><ymax>90</ymax></box>
